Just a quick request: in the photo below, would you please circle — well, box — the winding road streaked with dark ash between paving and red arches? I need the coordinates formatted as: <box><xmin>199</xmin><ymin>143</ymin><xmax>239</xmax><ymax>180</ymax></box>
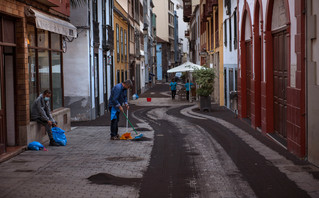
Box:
<box><xmin>134</xmin><ymin>85</ymin><xmax>319</xmax><ymax>198</ymax></box>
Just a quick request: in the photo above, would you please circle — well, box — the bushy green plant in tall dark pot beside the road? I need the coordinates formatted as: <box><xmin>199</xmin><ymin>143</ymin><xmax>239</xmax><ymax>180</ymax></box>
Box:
<box><xmin>194</xmin><ymin>68</ymin><xmax>216</xmax><ymax>111</ymax></box>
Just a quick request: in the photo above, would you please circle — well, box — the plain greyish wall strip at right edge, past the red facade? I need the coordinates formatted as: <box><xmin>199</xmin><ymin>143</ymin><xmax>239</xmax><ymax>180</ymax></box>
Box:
<box><xmin>306</xmin><ymin>0</ymin><xmax>319</xmax><ymax>166</ymax></box>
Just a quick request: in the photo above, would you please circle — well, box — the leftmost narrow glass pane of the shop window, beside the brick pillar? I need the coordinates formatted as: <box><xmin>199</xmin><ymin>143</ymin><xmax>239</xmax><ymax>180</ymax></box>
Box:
<box><xmin>28</xmin><ymin>49</ymin><xmax>38</xmax><ymax>107</ymax></box>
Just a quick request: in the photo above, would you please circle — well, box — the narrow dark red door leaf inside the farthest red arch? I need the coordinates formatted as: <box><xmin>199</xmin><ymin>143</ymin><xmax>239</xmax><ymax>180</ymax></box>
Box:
<box><xmin>246</xmin><ymin>41</ymin><xmax>252</xmax><ymax>118</ymax></box>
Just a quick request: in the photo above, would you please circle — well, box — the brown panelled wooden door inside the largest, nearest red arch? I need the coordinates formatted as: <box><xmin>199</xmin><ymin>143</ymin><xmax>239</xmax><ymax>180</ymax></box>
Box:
<box><xmin>273</xmin><ymin>31</ymin><xmax>288</xmax><ymax>138</ymax></box>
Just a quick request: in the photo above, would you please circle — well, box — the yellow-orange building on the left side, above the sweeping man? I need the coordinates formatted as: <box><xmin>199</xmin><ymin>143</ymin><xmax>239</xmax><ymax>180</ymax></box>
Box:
<box><xmin>113</xmin><ymin>1</ymin><xmax>129</xmax><ymax>84</ymax></box>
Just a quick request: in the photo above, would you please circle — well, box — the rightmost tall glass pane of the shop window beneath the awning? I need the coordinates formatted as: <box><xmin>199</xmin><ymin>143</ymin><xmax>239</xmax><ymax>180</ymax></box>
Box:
<box><xmin>52</xmin><ymin>52</ymin><xmax>63</xmax><ymax>109</ymax></box>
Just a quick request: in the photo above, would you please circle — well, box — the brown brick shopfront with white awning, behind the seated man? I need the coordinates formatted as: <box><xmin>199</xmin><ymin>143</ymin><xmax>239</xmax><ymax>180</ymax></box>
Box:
<box><xmin>0</xmin><ymin>0</ymin><xmax>77</xmax><ymax>154</ymax></box>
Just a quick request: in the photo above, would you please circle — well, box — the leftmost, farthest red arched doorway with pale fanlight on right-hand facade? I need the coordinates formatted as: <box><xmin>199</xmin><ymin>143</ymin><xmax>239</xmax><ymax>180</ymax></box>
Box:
<box><xmin>240</xmin><ymin>2</ymin><xmax>254</xmax><ymax>119</ymax></box>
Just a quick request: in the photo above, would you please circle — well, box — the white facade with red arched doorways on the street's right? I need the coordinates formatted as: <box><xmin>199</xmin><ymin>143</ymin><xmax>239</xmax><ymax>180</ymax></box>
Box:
<box><xmin>237</xmin><ymin>0</ymin><xmax>306</xmax><ymax>157</ymax></box>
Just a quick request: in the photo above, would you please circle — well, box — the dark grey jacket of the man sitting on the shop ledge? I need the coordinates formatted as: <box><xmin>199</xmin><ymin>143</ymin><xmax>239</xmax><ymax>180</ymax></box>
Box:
<box><xmin>31</xmin><ymin>94</ymin><xmax>55</xmax><ymax>122</ymax></box>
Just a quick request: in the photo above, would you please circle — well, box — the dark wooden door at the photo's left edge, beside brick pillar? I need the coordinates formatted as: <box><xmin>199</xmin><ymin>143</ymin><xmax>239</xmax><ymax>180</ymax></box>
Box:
<box><xmin>0</xmin><ymin>46</ymin><xmax>6</xmax><ymax>154</ymax></box>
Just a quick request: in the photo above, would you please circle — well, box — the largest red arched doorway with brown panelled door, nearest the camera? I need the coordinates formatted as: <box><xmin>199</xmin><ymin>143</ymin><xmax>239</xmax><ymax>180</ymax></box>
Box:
<box><xmin>265</xmin><ymin>0</ymin><xmax>290</xmax><ymax>139</ymax></box>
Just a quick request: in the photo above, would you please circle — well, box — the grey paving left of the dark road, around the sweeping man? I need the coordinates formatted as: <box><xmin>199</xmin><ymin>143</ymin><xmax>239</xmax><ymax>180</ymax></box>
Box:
<box><xmin>0</xmin><ymin>123</ymin><xmax>154</xmax><ymax>198</ymax></box>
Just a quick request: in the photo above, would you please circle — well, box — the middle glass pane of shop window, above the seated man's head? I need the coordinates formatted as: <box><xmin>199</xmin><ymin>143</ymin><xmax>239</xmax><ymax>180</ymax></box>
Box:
<box><xmin>38</xmin><ymin>50</ymin><xmax>50</xmax><ymax>93</ymax></box>
